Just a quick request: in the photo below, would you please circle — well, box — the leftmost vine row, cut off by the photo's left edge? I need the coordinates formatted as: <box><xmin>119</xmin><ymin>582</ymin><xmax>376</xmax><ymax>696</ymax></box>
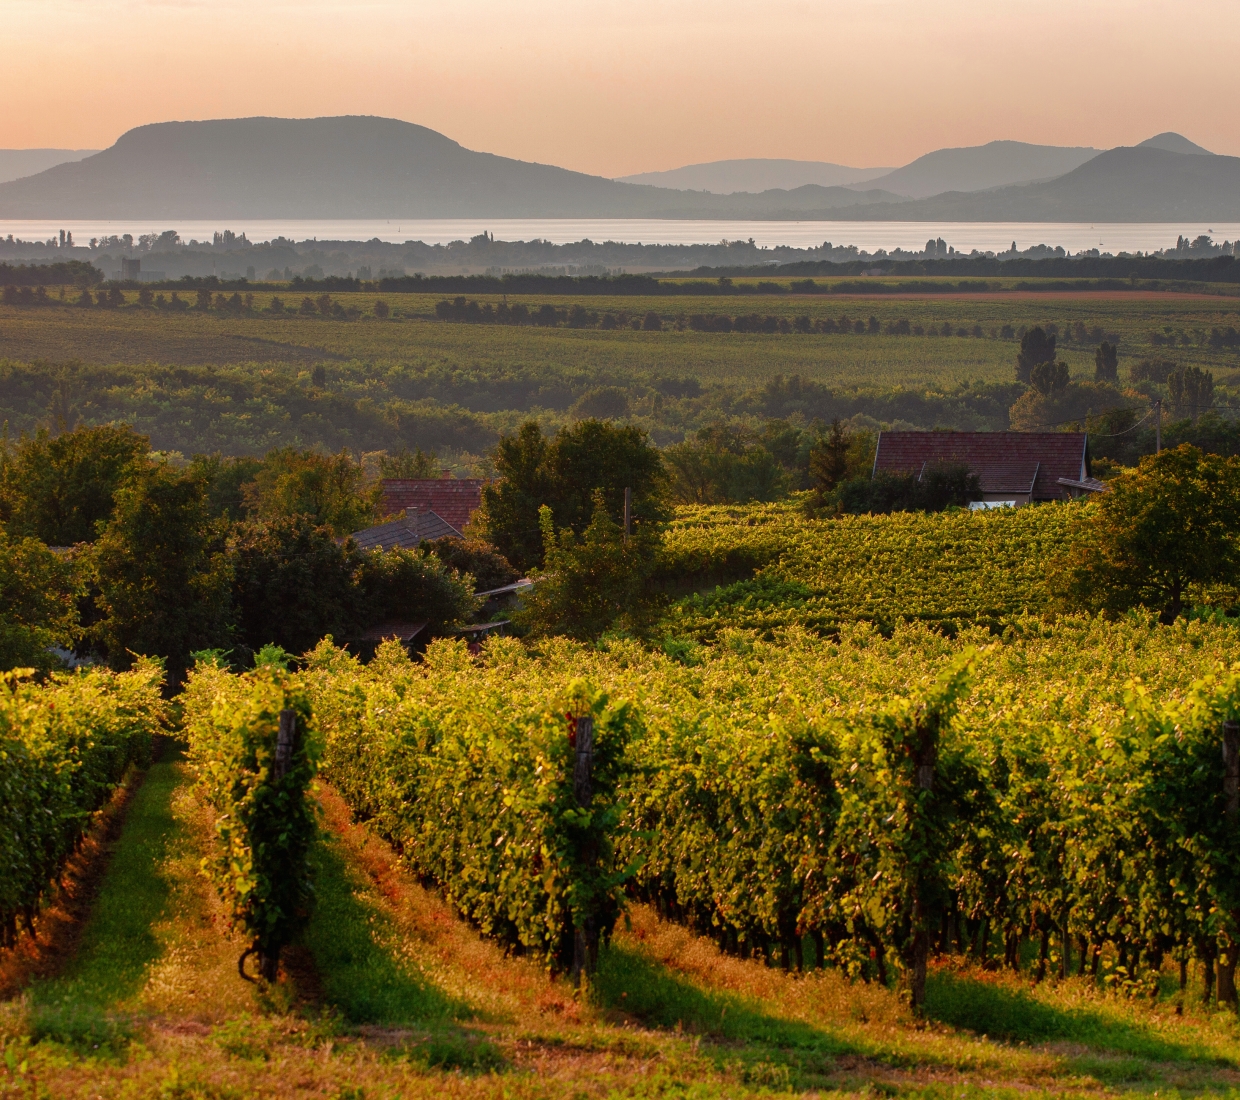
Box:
<box><xmin>0</xmin><ymin>661</ymin><xmax>165</xmax><ymax>946</ymax></box>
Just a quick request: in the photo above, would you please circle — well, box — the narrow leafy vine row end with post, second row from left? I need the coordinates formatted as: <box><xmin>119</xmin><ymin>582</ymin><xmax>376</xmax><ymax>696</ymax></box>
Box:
<box><xmin>181</xmin><ymin>663</ymin><xmax>320</xmax><ymax>977</ymax></box>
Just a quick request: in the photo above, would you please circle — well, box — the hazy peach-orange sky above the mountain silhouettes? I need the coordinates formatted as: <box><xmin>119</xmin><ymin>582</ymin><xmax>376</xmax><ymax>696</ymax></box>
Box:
<box><xmin>0</xmin><ymin>0</ymin><xmax>1240</xmax><ymax>176</ymax></box>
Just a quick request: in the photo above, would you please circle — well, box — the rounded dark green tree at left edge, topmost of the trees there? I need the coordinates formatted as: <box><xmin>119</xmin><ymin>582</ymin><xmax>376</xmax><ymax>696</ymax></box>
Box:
<box><xmin>0</xmin><ymin>425</ymin><xmax>150</xmax><ymax>546</ymax></box>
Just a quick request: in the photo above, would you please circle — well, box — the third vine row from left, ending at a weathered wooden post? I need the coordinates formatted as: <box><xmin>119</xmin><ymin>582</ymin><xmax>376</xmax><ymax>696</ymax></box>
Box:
<box><xmin>303</xmin><ymin>641</ymin><xmax>640</xmax><ymax>970</ymax></box>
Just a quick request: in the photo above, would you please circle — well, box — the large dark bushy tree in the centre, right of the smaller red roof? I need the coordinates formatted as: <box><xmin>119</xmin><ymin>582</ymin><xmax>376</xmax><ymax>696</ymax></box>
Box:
<box><xmin>475</xmin><ymin>420</ymin><xmax>667</xmax><ymax>569</ymax></box>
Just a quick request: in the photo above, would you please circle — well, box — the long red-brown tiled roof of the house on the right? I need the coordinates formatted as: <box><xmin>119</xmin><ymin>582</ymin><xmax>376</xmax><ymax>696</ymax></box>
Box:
<box><xmin>874</xmin><ymin>432</ymin><xmax>1089</xmax><ymax>500</ymax></box>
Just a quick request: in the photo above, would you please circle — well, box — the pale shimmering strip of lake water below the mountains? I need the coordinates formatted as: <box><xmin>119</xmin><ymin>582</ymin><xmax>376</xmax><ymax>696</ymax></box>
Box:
<box><xmin>0</xmin><ymin>218</ymin><xmax>1240</xmax><ymax>253</ymax></box>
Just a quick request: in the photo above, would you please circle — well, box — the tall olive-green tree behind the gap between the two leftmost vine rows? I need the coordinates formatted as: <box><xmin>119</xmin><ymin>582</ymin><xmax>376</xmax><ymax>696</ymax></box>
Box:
<box><xmin>86</xmin><ymin>465</ymin><xmax>229</xmax><ymax>683</ymax></box>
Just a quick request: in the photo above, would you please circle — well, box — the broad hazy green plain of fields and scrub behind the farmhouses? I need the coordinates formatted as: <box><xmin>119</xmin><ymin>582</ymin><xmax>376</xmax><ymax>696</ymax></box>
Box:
<box><xmin>0</xmin><ymin>284</ymin><xmax>1240</xmax><ymax>466</ymax></box>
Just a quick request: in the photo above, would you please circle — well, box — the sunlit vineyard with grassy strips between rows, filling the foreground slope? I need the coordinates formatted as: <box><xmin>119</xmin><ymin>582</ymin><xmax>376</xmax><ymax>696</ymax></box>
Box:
<box><xmin>0</xmin><ymin>505</ymin><xmax>1240</xmax><ymax>1100</ymax></box>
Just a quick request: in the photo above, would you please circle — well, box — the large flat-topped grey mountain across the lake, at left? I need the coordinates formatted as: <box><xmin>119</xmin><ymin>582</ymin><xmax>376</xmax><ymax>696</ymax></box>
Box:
<box><xmin>0</xmin><ymin>115</ymin><xmax>899</xmax><ymax>221</ymax></box>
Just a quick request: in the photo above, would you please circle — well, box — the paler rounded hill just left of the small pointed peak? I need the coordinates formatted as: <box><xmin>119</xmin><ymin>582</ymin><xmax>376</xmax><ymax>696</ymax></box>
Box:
<box><xmin>869</xmin><ymin>141</ymin><xmax>1099</xmax><ymax>198</ymax></box>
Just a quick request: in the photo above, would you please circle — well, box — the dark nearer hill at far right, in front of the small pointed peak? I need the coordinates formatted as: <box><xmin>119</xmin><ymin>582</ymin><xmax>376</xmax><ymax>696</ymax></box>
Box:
<box><xmin>836</xmin><ymin>145</ymin><xmax>1240</xmax><ymax>222</ymax></box>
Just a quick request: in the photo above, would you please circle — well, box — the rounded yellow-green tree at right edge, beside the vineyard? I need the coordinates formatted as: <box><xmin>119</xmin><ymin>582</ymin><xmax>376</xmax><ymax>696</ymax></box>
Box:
<box><xmin>1056</xmin><ymin>443</ymin><xmax>1240</xmax><ymax>623</ymax></box>
